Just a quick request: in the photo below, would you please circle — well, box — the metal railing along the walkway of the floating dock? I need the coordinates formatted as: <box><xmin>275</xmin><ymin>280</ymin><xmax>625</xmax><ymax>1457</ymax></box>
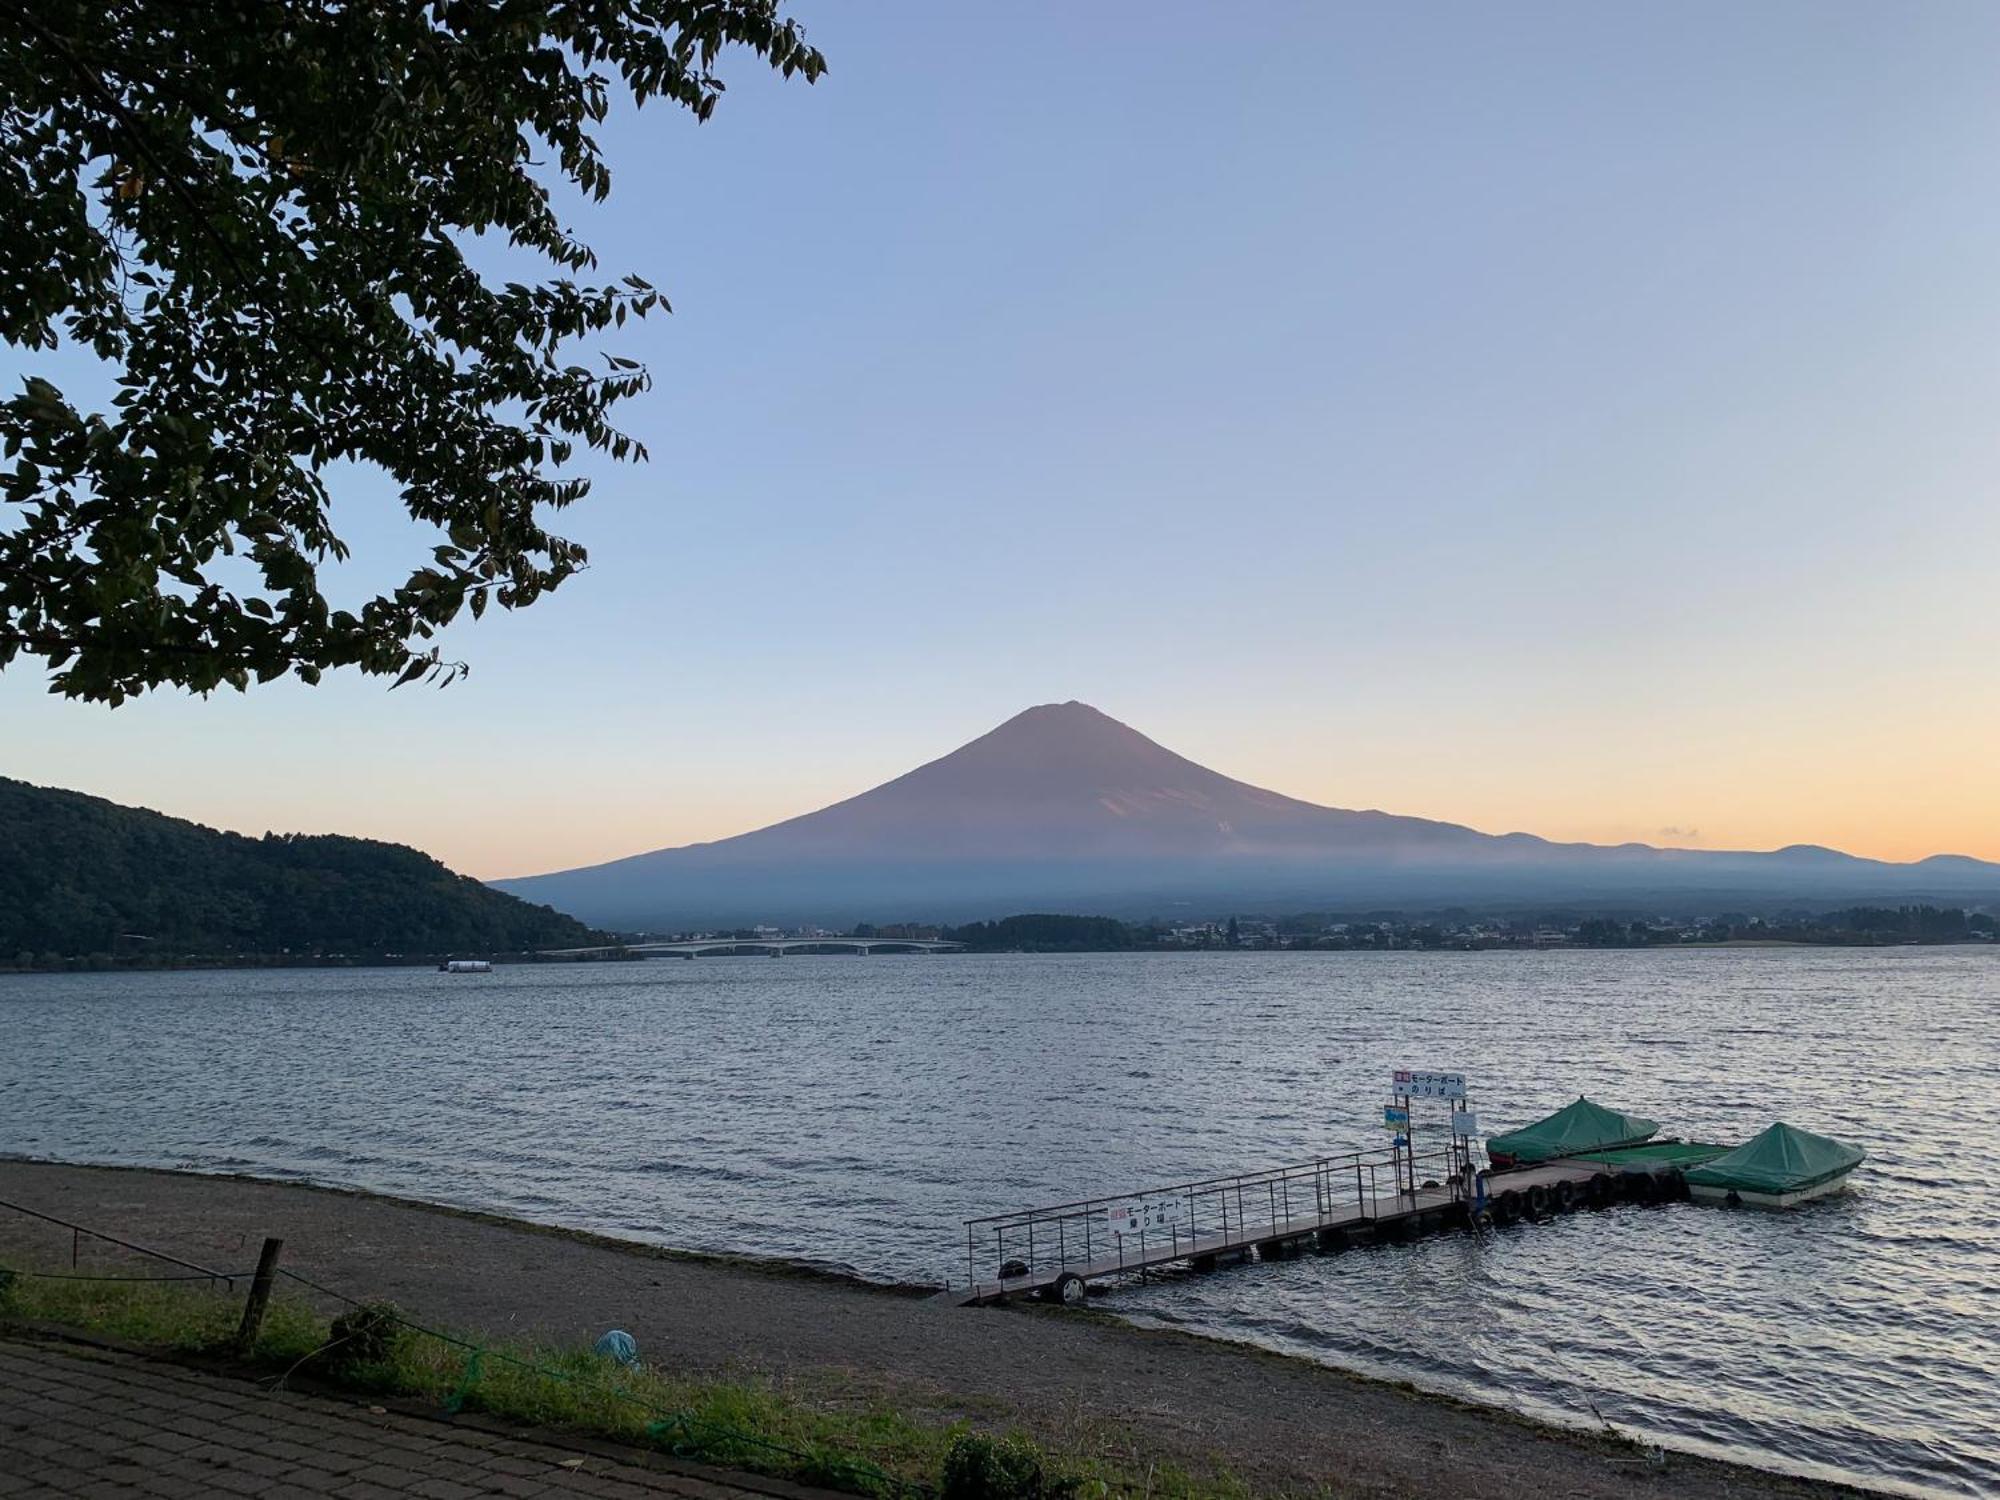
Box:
<box><xmin>966</xmin><ymin>1146</ymin><xmax>1462</xmax><ymax>1286</ymax></box>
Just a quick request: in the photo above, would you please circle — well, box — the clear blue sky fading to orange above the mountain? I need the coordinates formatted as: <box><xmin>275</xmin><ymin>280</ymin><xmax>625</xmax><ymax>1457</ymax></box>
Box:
<box><xmin>0</xmin><ymin>0</ymin><xmax>2000</xmax><ymax>878</ymax></box>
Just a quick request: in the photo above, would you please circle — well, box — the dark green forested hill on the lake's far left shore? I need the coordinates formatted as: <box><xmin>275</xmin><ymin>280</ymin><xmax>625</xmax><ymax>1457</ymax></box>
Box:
<box><xmin>0</xmin><ymin>776</ymin><xmax>594</xmax><ymax>966</ymax></box>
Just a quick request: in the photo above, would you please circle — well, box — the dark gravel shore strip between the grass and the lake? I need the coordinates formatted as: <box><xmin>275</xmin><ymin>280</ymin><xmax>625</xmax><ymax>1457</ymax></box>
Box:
<box><xmin>0</xmin><ymin>1160</ymin><xmax>1858</xmax><ymax>1500</ymax></box>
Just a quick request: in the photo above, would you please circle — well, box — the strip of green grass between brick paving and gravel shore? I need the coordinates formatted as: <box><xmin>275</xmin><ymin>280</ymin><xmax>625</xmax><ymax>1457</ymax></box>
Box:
<box><xmin>0</xmin><ymin>1270</ymin><xmax>1248</xmax><ymax>1500</ymax></box>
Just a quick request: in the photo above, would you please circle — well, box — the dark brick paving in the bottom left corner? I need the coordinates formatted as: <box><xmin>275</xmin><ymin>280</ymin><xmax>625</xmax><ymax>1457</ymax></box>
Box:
<box><xmin>0</xmin><ymin>1338</ymin><xmax>812</xmax><ymax>1500</ymax></box>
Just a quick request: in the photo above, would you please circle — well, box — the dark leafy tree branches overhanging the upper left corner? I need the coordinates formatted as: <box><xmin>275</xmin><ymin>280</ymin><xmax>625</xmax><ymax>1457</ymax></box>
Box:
<box><xmin>0</xmin><ymin>0</ymin><xmax>824</xmax><ymax>704</ymax></box>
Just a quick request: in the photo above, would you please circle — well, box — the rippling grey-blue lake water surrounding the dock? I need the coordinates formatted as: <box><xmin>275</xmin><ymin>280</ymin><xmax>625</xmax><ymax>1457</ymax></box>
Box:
<box><xmin>0</xmin><ymin>948</ymin><xmax>2000</xmax><ymax>1494</ymax></box>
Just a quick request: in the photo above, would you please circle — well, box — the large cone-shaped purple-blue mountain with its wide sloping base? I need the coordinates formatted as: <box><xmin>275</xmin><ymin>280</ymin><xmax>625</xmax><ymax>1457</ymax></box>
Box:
<box><xmin>494</xmin><ymin>702</ymin><xmax>2000</xmax><ymax>930</ymax></box>
